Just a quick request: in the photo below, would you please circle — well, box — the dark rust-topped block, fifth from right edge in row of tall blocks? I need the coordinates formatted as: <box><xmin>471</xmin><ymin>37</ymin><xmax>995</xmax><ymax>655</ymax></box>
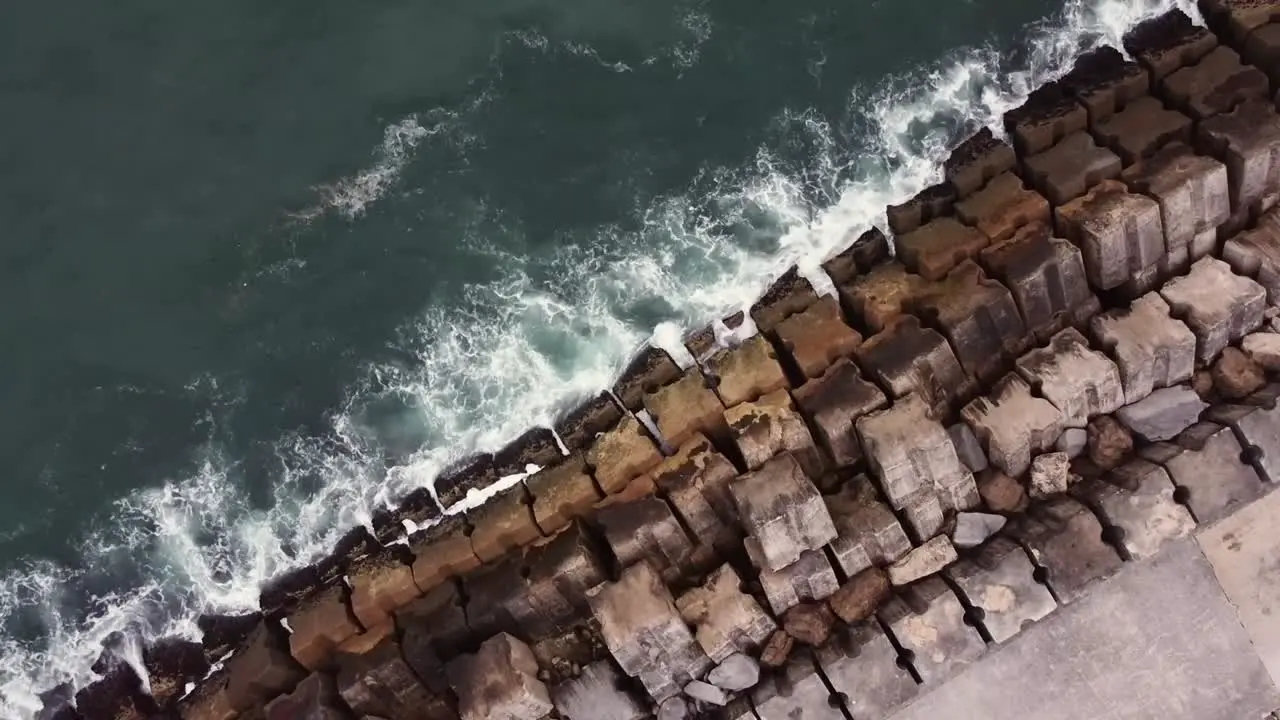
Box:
<box><xmin>916</xmin><ymin>261</ymin><xmax>1029</xmax><ymax>382</ymax></box>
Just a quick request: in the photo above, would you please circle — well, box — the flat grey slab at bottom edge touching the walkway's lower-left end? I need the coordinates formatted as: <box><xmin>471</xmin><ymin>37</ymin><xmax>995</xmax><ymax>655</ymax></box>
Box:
<box><xmin>815</xmin><ymin>623</ymin><xmax>918</xmax><ymax>720</ymax></box>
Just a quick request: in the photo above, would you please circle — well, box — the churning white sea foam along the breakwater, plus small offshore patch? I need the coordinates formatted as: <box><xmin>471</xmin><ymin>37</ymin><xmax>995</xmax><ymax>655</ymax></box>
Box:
<box><xmin>0</xmin><ymin>0</ymin><xmax>1196</xmax><ymax>717</ymax></box>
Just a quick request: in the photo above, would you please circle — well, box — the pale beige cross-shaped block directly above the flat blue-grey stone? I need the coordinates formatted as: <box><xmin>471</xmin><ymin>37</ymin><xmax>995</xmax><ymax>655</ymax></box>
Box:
<box><xmin>1089</xmin><ymin>292</ymin><xmax>1196</xmax><ymax>405</ymax></box>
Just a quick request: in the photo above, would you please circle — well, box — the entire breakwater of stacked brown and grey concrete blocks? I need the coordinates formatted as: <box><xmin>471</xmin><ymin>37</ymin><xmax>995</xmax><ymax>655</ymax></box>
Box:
<box><xmin>45</xmin><ymin>0</ymin><xmax>1280</xmax><ymax>720</ymax></box>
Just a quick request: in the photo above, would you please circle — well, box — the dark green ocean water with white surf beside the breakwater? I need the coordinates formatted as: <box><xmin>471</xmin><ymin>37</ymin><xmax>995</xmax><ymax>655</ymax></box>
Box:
<box><xmin>0</xmin><ymin>0</ymin><xmax>1196</xmax><ymax>717</ymax></box>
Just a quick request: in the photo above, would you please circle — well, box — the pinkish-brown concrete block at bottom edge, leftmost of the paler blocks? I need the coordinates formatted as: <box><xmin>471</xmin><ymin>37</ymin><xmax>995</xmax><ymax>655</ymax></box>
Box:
<box><xmin>448</xmin><ymin>633</ymin><xmax>554</xmax><ymax>720</ymax></box>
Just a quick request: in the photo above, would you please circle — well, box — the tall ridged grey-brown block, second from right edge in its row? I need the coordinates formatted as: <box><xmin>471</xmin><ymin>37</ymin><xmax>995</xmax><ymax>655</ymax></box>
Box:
<box><xmin>1124</xmin><ymin>142</ymin><xmax>1231</xmax><ymax>260</ymax></box>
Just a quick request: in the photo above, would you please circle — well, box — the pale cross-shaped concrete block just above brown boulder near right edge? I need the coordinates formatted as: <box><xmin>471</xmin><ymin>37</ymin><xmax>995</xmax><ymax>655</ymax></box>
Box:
<box><xmin>1160</xmin><ymin>258</ymin><xmax>1266</xmax><ymax>364</ymax></box>
